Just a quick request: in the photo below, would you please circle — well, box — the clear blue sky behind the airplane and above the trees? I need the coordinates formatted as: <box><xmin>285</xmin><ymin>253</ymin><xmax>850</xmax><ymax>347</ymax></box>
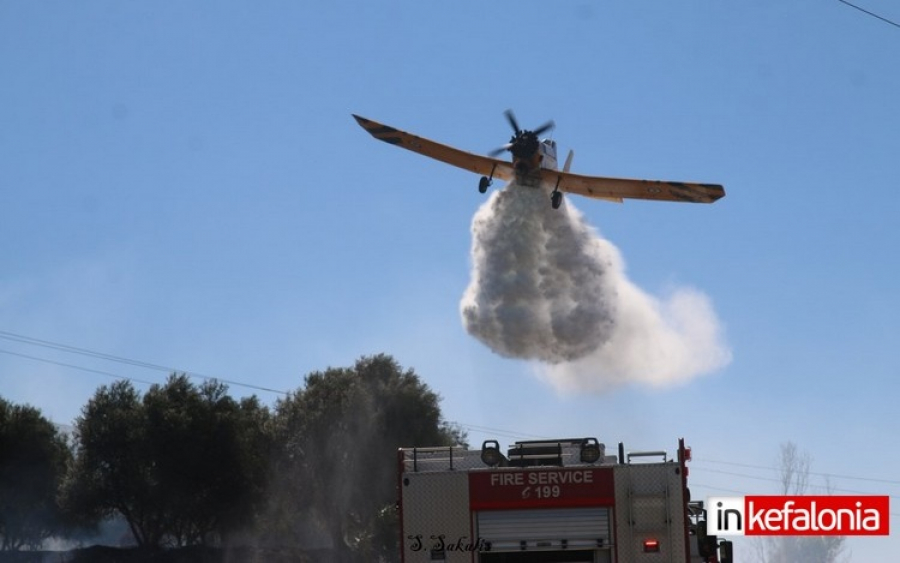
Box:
<box><xmin>0</xmin><ymin>0</ymin><xmax>900</xmax><ymax>561</ymax></box>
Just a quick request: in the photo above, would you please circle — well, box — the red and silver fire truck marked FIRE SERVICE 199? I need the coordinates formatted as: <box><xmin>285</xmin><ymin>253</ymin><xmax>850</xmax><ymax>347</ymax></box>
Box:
<box><xmin>398</xmin><ymin>438</ymin><xmax>733</xmax><ymax>563</ymax></box>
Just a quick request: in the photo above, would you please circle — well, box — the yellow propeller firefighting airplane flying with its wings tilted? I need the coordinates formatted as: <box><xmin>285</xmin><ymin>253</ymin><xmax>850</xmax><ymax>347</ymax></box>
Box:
<box><xmin>353</xmin><ymin>110</ymin><xmax>725</xmax><ymax>209</ymax></box>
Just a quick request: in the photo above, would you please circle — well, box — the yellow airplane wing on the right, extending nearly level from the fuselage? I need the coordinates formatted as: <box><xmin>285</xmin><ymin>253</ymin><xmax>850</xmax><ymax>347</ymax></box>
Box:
<box><xmin>541</xmin><ymin>169</ymin><xmax>725</xmax><ymax>203</ymax></box>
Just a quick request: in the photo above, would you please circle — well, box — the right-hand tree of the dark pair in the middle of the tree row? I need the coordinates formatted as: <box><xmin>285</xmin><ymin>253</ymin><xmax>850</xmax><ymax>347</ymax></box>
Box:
<box><xmin>144</xmin><ymin>375</ymin><xmax>269</xmax><ymax>545</ymax></box>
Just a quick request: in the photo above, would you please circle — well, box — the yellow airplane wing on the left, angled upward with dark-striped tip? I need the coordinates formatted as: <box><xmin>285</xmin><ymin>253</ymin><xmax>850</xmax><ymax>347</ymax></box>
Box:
<box><xmin>353</xmin><ymin>114</ymin><xmax>515</xmax><ymax>180</ymax></box>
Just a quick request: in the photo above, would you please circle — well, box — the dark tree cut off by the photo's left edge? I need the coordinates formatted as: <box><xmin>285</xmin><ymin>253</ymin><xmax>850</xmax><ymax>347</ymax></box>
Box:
<box><xmin>0</xmin><ymin>398</ymin><xmax>71</xmax><ymax>550</ymax></box>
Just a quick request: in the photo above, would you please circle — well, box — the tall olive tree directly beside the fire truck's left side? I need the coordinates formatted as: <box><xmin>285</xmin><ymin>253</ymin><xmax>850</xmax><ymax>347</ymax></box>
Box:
<box><xmin>272</xmin><ymin>355</ymin><xmax>465</xmax><ymax>561</ymax></box>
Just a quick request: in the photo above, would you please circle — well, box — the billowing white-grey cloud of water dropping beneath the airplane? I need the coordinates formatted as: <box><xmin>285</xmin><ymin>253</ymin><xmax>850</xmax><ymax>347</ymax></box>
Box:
<box><xmin>460</xmin><ymin>185</ymin><xmax>731</xmax><ymax>392</ymax></box>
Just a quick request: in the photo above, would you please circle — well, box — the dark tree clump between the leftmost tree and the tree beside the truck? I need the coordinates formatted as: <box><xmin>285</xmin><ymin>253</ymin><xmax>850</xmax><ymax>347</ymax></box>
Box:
<box><xmin>63</xmin><ymin>374</ymin><xmax>271</xmax><ymax>547</ymax></box>
